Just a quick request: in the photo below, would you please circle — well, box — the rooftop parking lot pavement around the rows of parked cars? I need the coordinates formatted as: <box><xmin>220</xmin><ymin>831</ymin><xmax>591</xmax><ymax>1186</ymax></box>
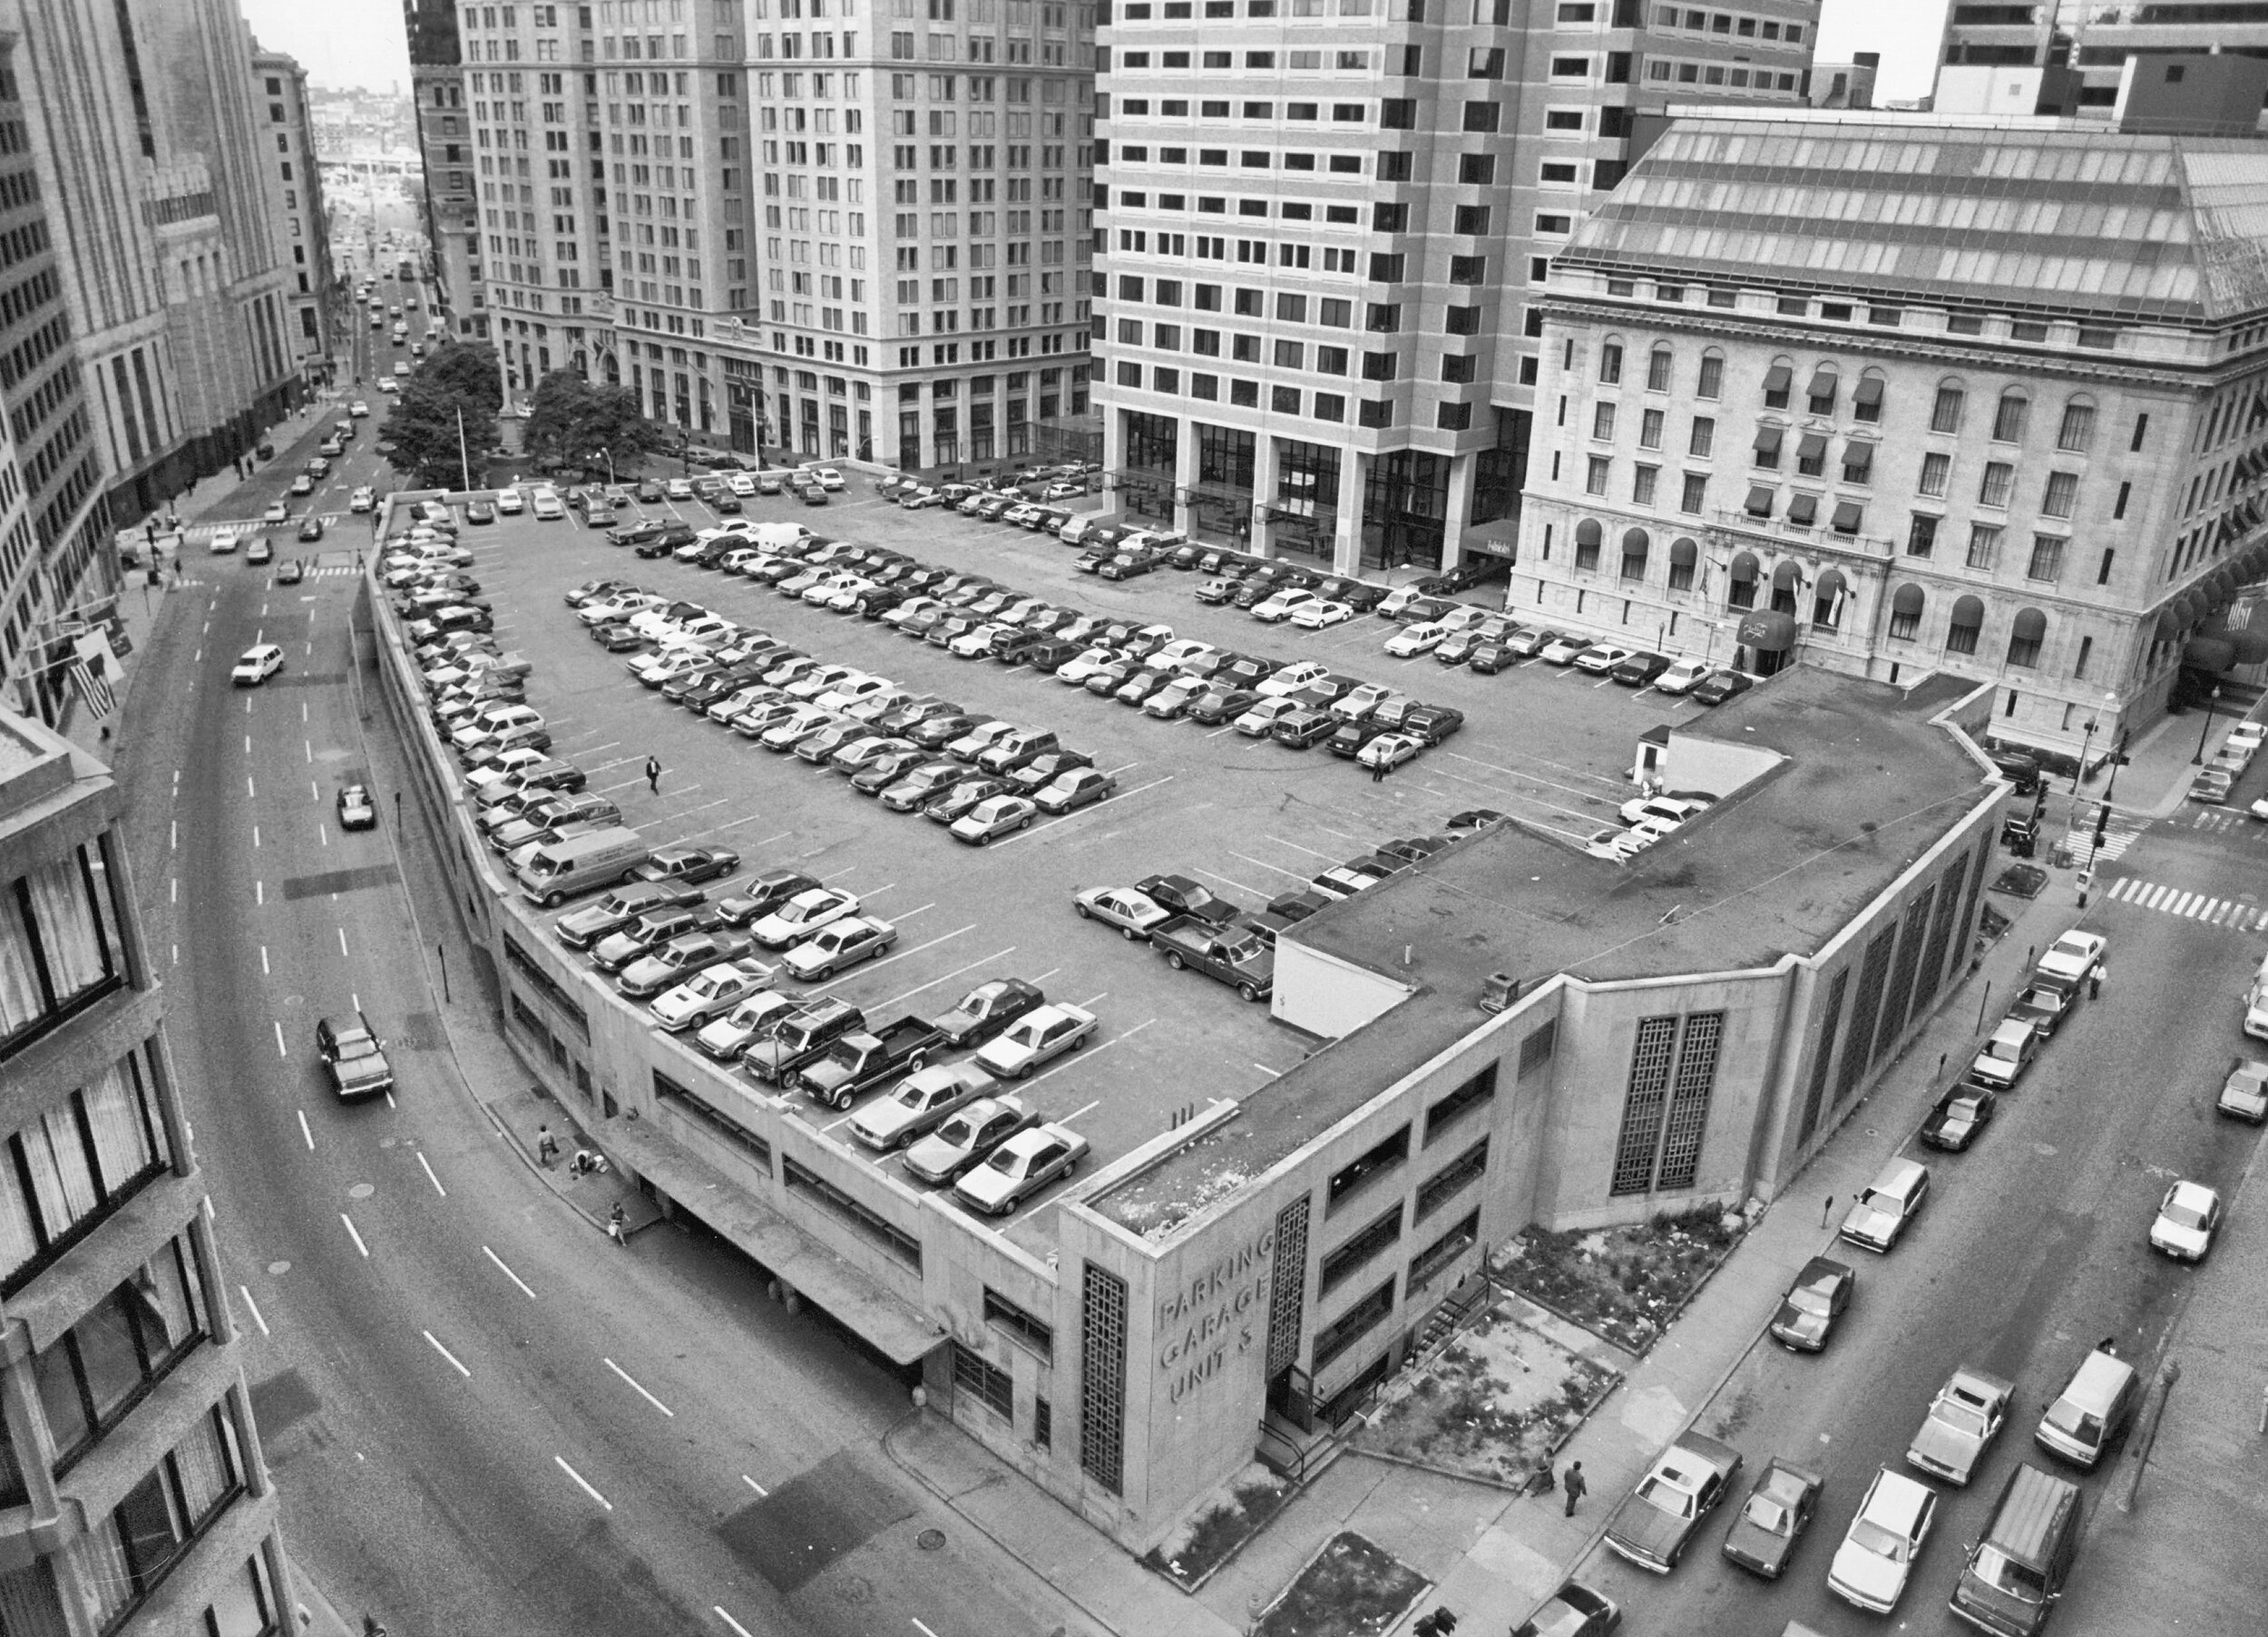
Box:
<box><xmin>413</xmin><ymin>476</ymin><xmax>1751</xmax><ymax>1250</ymax></box>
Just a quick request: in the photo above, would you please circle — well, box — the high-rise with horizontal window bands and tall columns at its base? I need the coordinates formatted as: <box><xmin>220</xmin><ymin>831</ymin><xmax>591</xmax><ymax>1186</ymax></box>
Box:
<box><xmin>1093</xmin><ymin>0</ymin><xmax>1819</xmax><ymax>574</ymax></box>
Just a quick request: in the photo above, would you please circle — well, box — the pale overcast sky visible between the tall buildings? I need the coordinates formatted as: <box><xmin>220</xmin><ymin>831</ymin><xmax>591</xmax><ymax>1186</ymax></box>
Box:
<box><xmin>239</xmin><ymin>0</ymin><xmax>1946</xmax><ymax>100</ymax></box>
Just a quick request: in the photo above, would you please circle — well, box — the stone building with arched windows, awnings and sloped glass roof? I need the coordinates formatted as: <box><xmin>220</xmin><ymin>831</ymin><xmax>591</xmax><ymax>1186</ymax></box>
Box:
<box><xmin>1506</xmin><ymin>109</ymin><xmax>2268</xmax><ymax>751</ymax></box>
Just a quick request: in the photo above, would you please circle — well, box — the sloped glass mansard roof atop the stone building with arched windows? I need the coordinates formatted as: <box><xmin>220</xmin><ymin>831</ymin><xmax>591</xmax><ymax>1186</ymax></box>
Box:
<box><xmin>1560</xmin><ymin>118</ymin><xmax>2268</xmax><ymax>325</ymax></box>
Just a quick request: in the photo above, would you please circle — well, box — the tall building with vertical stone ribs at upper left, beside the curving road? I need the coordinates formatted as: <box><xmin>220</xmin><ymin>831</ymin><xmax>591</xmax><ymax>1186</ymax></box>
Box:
<box><xmin>0</xmin><ymin>0</ymin><xmax>299</xmax><ymax>523</ymax></box>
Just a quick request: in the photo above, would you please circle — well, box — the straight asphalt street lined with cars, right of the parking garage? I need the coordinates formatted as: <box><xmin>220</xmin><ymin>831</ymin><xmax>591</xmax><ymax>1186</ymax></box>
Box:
<box><xmin>1581</xmin><ymin>771</ymin><xmax>2268</xmax><ymax>1637</ymax></box>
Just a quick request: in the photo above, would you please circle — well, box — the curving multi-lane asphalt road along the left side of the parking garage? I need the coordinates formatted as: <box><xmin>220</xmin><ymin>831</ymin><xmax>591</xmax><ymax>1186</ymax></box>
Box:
<box><xmin>121</xmin><ymin>438</ymin><xmax>1107</xmax><ymax>1637</ymax></box>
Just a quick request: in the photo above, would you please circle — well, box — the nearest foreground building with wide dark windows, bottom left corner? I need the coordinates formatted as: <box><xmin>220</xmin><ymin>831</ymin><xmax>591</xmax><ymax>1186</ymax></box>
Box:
<box><xmin>0</xmin><ymin>715</ymin><xmax>293</xmax><ymax>1637</ymax></box>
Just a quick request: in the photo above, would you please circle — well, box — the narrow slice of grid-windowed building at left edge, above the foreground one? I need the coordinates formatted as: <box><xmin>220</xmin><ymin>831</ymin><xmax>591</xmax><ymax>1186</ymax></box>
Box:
<box><xmin>0</xmin><ymin>34</ymin><xmax>109</xmax><ymax>715</ymax></box>
